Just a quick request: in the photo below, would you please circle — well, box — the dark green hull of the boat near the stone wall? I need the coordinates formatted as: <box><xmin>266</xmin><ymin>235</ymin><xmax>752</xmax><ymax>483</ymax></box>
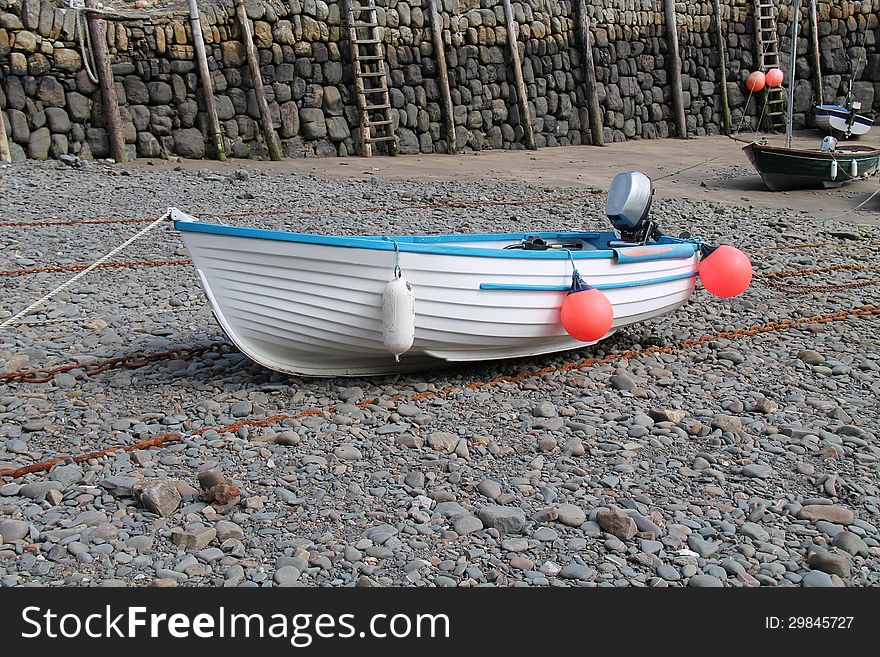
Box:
<box><xmin>743</xmin><ymin>144</ymin><xmax>880</xmax><ymax>191</ymax></box>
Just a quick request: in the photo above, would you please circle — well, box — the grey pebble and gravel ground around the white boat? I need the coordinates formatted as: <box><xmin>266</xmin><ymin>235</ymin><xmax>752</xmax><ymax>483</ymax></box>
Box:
<box><xmin>0</xmin><ymin>162</ymin><xmax>880</xmax><ymax>586</ymax></box>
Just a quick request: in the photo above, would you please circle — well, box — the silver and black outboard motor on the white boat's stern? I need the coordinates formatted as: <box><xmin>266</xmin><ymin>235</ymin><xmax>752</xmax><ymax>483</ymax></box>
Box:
<box><xmin>605</xmin><ymin>171</ymin><xmax>660</xmax><ymax>244</ymax></box>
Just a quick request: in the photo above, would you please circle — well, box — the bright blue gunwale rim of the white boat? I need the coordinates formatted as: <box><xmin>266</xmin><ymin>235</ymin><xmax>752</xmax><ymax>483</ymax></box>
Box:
<box><xmin>174</xmin><ymin>220</ymin><xmax>700</xmax><ymax>260</ymax></box>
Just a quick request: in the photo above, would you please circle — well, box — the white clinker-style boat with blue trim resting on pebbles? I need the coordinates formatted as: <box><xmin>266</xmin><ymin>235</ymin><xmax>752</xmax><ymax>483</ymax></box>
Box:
<box><xmin>170</xmin><ymin>174</ymin><xmax>700</xmax><ymax>376</ymax></box>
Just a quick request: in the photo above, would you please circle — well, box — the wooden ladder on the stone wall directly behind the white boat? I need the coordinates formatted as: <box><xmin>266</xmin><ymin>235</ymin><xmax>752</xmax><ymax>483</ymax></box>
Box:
<box><xmin>345</xmin><ymin>0</ymin><xmax>398</xmax><ymax>157</ymax></box>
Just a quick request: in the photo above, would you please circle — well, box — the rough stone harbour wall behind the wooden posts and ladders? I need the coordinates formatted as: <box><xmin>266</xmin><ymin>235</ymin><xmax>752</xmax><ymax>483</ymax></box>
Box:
<box><xmin>0</xmin><ymin>0</ymin><xmax>880</xmax><ymax>159</ymax></box>
